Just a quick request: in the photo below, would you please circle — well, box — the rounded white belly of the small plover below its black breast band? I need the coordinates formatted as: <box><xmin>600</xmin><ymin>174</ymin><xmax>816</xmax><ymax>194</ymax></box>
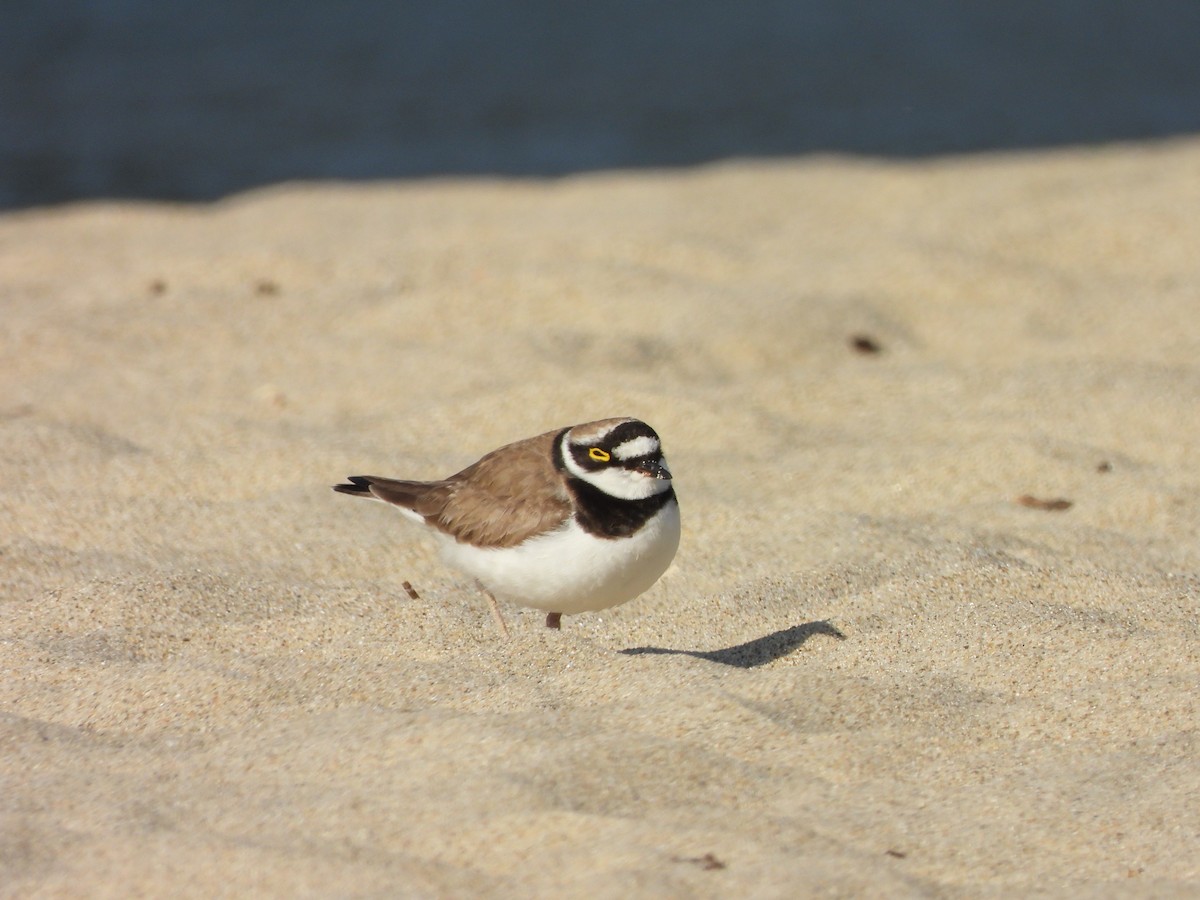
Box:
<box><xmin>442</xmin><ymin>500</ymin><xmax>679</xmax><ymax>613</ymax></box>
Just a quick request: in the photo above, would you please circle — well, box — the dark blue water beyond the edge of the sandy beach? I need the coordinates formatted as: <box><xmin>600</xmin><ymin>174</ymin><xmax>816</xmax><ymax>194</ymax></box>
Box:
<box><xmin>0</xmin><ymin>0</ymin><xmax>1200</xmax><ymax>208</ymax></box>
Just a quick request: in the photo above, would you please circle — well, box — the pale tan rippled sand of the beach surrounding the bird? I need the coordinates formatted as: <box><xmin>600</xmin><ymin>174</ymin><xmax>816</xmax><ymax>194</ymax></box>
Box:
<box><xmin>0</xmin><ymin>139</ymin><xmax>1200</xmax><ymax>898</ymax></box>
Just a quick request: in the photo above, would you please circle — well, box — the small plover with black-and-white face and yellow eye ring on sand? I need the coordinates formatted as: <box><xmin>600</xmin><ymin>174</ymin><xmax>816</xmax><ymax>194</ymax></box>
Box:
<box><xmin>334</xmin><ymin>416</ymin><xmax>680</xmax><ymax>636</ymax></box>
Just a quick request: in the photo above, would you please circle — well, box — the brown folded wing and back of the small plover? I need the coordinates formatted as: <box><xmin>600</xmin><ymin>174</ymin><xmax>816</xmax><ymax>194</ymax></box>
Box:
<box><xmin>422</xmin><ymin>431</ymin><xmax>571</xmax><ymax>547</ymax></box>
